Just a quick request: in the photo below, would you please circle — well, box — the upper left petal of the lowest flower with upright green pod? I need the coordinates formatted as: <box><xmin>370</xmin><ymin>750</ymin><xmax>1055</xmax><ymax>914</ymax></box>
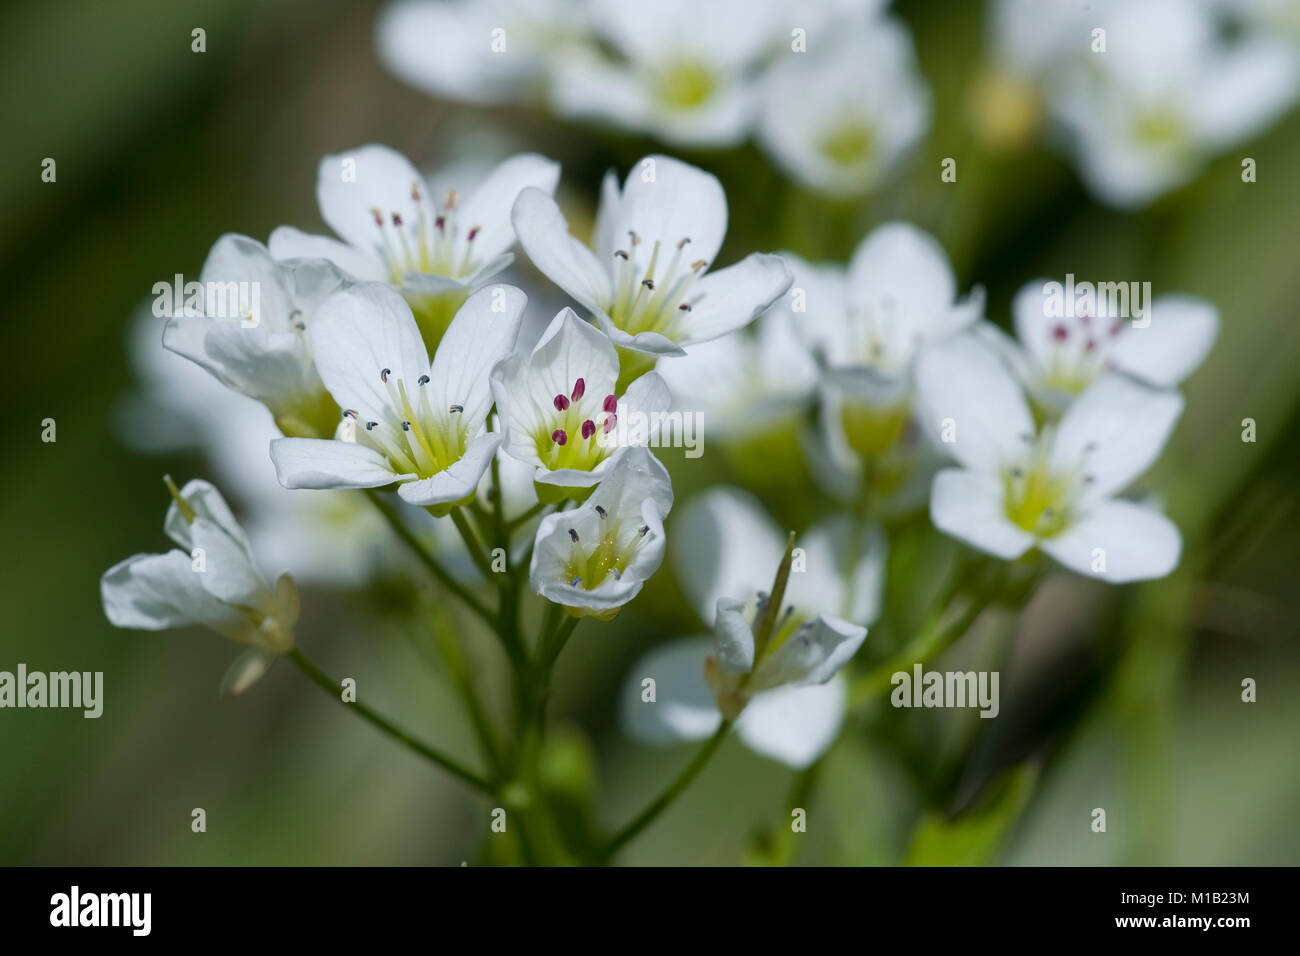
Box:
<box><xmin>672</xmin><ymin>488</ymin><xmax>785</xmax><ymax>622</ymax></box>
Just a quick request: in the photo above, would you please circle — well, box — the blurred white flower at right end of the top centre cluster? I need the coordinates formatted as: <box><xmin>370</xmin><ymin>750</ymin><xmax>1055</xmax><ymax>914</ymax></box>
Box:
<box><xmin>758</xmin><ymin>18</ymin><xmax>931</xmax><ymax>196</ymax></box>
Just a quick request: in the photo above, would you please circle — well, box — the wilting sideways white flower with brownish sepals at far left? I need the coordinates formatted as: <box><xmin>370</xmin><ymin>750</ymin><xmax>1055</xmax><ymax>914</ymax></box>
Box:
<box><xmin>100</xmin><ymin>480</ymin><xmax>298</xmax><ymax>693</ymax></box>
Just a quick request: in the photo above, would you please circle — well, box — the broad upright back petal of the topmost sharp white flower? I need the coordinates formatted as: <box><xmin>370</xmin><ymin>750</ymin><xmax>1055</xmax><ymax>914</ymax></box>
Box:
<box><xmin>614</xmin><ymin>155</ymin><xmax>727</xmax><ymax>265</ymax></box>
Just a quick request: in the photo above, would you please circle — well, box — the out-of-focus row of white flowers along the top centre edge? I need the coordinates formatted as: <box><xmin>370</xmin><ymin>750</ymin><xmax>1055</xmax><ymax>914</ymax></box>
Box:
<box><xmin>377</xmin><ymin>0</ymin><xmax>931</xmax><ymax>195</ymax></box>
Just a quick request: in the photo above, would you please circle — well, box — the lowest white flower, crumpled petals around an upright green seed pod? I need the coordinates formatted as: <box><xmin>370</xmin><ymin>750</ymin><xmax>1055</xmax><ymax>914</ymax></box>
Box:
<box><xmin>620</xmin><ymin>488</ymin><xmax>885</xmax><ymax>767</ymax></box>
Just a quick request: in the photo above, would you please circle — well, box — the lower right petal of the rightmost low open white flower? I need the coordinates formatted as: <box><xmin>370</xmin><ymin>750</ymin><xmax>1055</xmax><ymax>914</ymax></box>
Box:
<box><xmin>1039</xmin><ymin>501</ymin><xmax>1183</xmax><ymax>584</ymax></box>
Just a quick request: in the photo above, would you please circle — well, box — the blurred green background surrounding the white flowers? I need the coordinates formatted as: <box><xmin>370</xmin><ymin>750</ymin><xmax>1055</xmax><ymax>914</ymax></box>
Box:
<box><xmin>0</xmin><ymin>0</ymin><xmax>1300</xmax><ymax>865</ymax></box>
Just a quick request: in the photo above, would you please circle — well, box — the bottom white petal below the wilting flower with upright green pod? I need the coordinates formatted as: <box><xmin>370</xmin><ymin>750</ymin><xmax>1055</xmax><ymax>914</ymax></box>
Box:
<box><xmin>736</xmin><ymin>676</ymin><xmax>849</xmax><ymax>770</ymax></box>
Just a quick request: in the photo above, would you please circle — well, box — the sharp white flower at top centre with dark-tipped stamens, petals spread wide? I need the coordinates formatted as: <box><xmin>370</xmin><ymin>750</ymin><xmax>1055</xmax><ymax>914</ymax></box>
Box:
<box><xmin>514</xmin><ymin>156</ymin><xmax>790</xmax><ymax>363</ymax></box>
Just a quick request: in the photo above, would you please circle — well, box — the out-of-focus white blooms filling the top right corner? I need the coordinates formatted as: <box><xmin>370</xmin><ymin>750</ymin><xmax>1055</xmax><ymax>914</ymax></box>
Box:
<box><xmin>991</xmin><ymin>0</ymin><xmax>1300</xmax><ymax>208</ymax></box>
